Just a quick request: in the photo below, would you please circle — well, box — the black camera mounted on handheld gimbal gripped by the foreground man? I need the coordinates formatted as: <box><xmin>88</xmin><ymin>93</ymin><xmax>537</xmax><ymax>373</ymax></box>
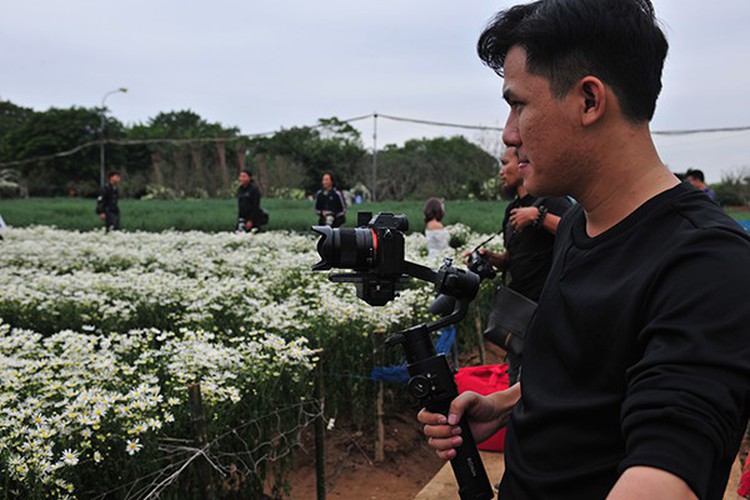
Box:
<box><xmin>313</xmin><ymin>213</ymin><xmax>494</xmax><ymax>500</ymax></box>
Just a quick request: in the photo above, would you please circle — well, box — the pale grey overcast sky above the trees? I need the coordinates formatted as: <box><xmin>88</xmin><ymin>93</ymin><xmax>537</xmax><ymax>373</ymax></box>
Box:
<box><xmin>0</xmin><ymin>0</ymin><xmax>750</xmax><ymax>182</ymax></box>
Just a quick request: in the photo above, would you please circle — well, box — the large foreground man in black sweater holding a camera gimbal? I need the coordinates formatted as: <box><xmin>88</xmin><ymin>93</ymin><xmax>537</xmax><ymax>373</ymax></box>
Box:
<box><xmin>418</xmin><ymin>0</ymin><xmax>750</xmax><ymax>500</ymax></box>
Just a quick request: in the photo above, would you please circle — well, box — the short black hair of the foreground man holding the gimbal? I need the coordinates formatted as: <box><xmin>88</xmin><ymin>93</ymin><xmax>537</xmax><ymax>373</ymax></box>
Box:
<box><xmin>477</xmin><ymin>0</ymin><xmax>668</xmax><ymax>123</ymax></box>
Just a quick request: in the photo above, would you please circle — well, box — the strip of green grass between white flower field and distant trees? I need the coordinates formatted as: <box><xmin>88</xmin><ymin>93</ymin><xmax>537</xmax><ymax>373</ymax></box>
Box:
<box><xmin>0</xmin><ymin>198</ymin><xmax>506</xmax><ymax>233</ymax></box>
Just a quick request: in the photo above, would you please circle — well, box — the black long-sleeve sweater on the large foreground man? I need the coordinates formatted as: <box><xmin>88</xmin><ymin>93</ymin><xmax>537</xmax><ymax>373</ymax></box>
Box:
<box><xmin>500</xmin><ymin>185</ymin><xmax>750</xmax><ymax>500</ymax></box>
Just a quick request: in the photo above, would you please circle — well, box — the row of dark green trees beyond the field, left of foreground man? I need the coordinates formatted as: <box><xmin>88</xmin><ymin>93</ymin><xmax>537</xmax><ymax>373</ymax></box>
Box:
<box><xmin>0</xmin><ymin>101</ymin><xmax>506</xmax><ymax>200</ymax></box>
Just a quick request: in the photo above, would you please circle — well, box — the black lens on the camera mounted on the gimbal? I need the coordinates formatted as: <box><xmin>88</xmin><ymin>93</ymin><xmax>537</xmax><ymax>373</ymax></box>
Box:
<box><xmin>313</xmin><ymin>226</ymin><xmax>377</xmax><ymax>271</ymax></box>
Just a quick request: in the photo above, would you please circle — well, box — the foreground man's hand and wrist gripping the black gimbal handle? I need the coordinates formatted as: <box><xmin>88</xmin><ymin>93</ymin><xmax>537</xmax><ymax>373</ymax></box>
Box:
<box><xmin>417</xmin><ymin>384</ymin><xmax>521</xmax><ymax>460</ymax></box>
